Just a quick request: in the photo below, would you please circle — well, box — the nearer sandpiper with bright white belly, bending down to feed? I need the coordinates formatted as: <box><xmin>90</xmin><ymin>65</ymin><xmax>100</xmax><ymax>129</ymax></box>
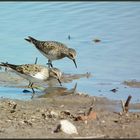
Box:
<box><xmin>0</xmin><ymin>62</ymin><xmax>62</xmax><ymax>93</ymax></box>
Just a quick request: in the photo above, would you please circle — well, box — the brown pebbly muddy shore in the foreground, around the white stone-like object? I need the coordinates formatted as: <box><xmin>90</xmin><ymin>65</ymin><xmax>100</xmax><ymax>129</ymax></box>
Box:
<box><xmin>0</xmin><ymin>94</ymin><xmax>140</xmax><ymax>138</ymax></box>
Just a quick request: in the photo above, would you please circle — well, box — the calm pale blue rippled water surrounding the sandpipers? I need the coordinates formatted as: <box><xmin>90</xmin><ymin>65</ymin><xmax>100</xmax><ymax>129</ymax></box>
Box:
<box><xmin>0</xmin><ymin>2</ymin><xmax>140</xmax><ymax>102</ymax></box>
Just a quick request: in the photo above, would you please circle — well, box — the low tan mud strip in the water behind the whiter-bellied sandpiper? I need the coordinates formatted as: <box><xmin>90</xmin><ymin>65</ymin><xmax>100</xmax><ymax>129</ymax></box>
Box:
<box><xmin>0</xmin><ymin>71</ymin><xmax>91</xmax><ymax>89</ymax></box>
